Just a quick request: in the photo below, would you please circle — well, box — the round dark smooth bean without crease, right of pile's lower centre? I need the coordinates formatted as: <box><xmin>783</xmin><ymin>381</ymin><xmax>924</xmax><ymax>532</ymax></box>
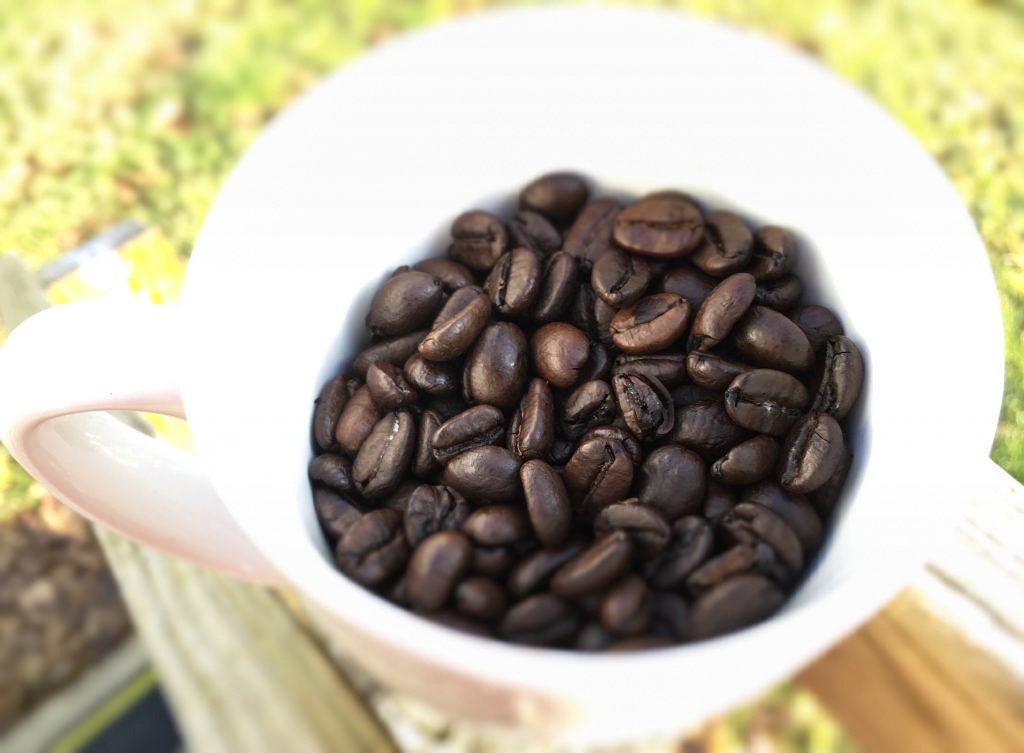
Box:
<box><xmin>637</xmin><ymin>445</ymin><xmax>707</xmax><ymax>520</ymax></box>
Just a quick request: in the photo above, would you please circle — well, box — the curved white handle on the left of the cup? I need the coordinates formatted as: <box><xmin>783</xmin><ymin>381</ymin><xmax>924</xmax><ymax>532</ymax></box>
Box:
<box><xmin>0</xmin><ymin>301</ymin><xmax>280</xmax><ymax>584</ymax></box>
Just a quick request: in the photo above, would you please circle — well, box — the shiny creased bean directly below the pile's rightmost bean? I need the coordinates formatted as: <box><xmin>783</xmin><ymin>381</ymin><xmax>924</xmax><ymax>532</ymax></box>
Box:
<box><xmin>778</xmin><ymin>413</ymin><xmax>845</xmax><ymax>494</ymax></box>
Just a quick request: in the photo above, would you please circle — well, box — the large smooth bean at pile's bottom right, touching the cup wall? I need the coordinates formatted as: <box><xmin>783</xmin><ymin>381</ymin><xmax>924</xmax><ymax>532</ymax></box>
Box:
<box><xmin>690</xmin><ymin>575</ymin><xmax>785</xmax><ymax>640</ymax></box>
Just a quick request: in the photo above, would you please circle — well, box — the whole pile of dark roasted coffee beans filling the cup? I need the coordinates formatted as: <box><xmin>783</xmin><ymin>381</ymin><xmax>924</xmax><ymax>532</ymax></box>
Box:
<box><xmin>309</xmin><ymin>173</ymin><xmax>864</xmax><ymax>651</ymax></box>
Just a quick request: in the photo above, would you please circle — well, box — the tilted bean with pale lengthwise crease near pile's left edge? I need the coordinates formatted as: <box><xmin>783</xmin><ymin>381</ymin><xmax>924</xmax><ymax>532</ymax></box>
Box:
<box><xmin>352</xmin><ymin>411</ymin><xmax>416</xmax><ymax>499</ymax></box>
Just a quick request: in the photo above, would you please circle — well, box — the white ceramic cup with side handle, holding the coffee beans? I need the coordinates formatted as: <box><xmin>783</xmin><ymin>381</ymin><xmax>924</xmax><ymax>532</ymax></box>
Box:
<box><xmin>0</xmin><ymin>8</ymin><xmax>1002</xmax><ymax>741</ymax></box>
